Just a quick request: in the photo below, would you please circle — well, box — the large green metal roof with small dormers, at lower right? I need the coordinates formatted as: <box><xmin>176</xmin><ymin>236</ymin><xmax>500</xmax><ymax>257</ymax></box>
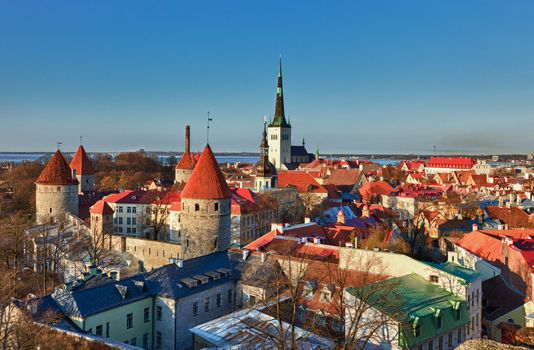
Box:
<box><xmin>347</xmin><ymin>273</ymin><xmax>469</xmax><ymax>347</ymax></box>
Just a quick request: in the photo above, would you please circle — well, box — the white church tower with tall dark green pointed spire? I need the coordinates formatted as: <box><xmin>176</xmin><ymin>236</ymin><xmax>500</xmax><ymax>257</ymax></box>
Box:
<box><xmin>267</xmin><ymin>59</ymin><xmax>291</xmax><ymax>169</ymax></box>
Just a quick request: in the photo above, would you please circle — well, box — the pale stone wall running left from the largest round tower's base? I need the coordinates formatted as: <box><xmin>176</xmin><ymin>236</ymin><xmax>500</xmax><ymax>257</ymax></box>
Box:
<box><xmin>111</xmin><ymin>235</ymin><xmax>182</xmax><ymax>271</ymax></box>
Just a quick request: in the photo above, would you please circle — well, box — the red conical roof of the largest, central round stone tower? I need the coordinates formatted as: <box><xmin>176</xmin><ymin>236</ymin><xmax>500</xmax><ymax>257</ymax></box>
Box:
<box><xmin>182</xmin><ymin>145</ymin><xmax>232</xmax><ymax>199</ymax></box>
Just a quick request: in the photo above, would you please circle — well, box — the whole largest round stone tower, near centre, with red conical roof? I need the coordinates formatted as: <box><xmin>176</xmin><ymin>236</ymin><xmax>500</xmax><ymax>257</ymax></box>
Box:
<box><xmin>180</xmin><ymin>145</ymin><xmax>232</xmax><ymax>259</ymax></box>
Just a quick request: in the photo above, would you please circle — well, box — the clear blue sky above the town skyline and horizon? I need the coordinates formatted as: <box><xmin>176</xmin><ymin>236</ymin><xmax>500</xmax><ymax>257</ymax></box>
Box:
<box><xmin>0</xmin><ymin>0</ymin><xmax>534</xmax><ymax>154</ymax></box>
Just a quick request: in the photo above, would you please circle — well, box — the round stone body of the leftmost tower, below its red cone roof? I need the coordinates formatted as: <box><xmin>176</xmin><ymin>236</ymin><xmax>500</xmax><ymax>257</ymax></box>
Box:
<box><xmin>35</xmin><ymin>184</ymin><xmax>78</xmax><ymax>224</ymax></box>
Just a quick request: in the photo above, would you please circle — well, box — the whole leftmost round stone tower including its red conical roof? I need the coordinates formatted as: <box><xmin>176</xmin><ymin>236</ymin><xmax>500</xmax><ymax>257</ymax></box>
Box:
<box><xmin>35</xmin><ymin>149</ymin><xmax>78</xmax><ymax>224</ymax></box>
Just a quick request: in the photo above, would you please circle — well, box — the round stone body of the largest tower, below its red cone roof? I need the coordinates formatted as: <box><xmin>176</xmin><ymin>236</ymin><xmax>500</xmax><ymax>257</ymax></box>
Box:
<box><xmin>180</xmin><ymin>198</ymin><xmax>230</xmax><ymax>259</ymax></box>
